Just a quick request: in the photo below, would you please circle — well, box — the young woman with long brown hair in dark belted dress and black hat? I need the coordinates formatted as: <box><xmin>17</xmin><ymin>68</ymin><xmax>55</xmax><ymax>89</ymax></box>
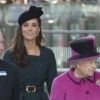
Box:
<box><xmin>3</xmin><ymin>6</ymin><xmax>57</xmax><ymax>100</ymax></box>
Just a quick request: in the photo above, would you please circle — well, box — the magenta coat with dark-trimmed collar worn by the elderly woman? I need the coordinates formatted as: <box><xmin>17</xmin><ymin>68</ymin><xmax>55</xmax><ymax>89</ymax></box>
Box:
<box><xmin>50</xmin><ymin>70</ymin><xmax>100</xmax><ymax>100</ymax></box>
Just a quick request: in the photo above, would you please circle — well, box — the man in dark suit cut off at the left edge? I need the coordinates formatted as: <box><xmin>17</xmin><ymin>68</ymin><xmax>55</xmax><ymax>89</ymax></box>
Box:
<box><xmin>0</xmin><ymin>31</ymin><xmax>19</xmax><ymax>100</ymax></box>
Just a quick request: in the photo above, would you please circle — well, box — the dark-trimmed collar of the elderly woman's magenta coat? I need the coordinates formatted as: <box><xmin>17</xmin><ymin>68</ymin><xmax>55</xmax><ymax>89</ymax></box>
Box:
<box><xmin>68</xmin><ymin>69</ymin><xmax>95</xmax><ymax>84</ymax></box>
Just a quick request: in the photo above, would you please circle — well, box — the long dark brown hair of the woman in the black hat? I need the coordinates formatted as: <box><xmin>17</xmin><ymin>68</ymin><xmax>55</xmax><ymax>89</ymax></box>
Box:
<box><xmin>11</xmin><ymin>18</ymin><xmax>43</xmax><ymax>66</ymax></box>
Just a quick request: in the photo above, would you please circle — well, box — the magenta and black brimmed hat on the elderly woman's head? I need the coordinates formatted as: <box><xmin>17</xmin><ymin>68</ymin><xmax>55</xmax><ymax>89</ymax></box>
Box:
<box><xmin>67</xmin><ymin>35</ymin><xmax>100</xmax><ymax>63</ymax></box>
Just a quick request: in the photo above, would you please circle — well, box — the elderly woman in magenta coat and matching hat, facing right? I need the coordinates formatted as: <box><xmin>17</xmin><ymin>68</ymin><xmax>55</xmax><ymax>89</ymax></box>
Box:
<box><xmin>50</xmin><ymin>36</ymin><xmax>100</xmax><ymax>100</ymax></box>
